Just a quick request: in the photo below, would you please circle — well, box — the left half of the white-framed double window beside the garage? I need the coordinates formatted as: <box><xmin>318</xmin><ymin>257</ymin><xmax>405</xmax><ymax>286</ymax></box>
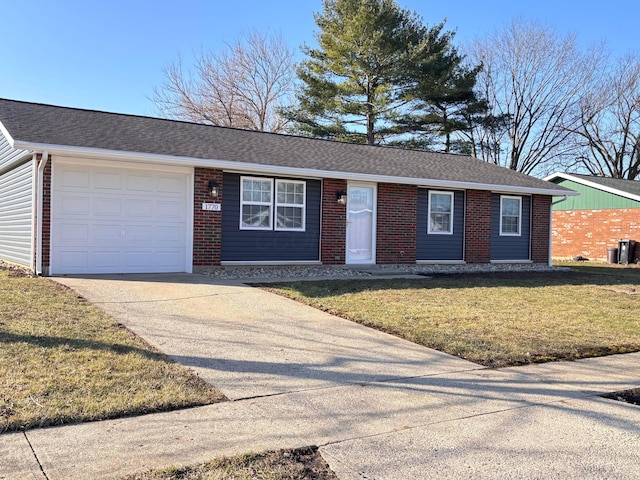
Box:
<box><xmin>240</xmin><ymin>177</ymin><xmax>273</xmax><ymax>230</ymax></box>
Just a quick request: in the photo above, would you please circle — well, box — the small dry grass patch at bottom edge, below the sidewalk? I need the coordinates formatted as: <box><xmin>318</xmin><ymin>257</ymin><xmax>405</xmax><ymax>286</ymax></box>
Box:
<box><xmin>122</xmin><ymin>447</ymin><xmax>337</xmax><ymax>480</ymax></box>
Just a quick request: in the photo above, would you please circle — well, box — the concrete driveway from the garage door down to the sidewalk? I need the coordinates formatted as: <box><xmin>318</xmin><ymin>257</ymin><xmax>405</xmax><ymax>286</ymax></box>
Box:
<box><xmin>55</xmin><ymin>274</ymin><xmax>481</xmax><ymax>400</ymax></box>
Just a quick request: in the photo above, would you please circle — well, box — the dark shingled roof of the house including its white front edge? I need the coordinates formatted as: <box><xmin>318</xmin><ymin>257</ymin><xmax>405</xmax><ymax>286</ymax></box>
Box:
<box><xmin>0</xmin><ymin>99</ymin><xmax>574</xmax><ymax>195</ymax></box>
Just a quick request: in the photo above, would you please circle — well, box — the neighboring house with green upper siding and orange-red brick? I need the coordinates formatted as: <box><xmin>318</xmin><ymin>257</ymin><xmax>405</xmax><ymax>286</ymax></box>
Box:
<box><xmin>545</xmin><ymin>173</ymin><xmax>640</xmax><ymax>261</ymax></box>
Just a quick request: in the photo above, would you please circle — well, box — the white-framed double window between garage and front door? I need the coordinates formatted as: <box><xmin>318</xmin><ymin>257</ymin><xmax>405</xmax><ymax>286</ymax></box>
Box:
<box><xmin>240</xmin><ymin>177</ymin><xmax>306</xmax><ymax>231</ymax></box>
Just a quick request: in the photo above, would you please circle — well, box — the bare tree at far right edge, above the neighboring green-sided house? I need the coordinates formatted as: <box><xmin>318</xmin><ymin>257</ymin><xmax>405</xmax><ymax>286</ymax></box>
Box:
<box><xmin>572</xmin><ymin>55</ymin><xmax>640</xmax><ymax>180</ymax></box>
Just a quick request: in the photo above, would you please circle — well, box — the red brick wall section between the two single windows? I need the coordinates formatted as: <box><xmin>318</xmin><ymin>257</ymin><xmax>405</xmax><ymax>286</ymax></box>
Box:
<box><xmin>464</xmin><ymin>190</ymin><xmax>491</xmax><ymax>263</ymax></box>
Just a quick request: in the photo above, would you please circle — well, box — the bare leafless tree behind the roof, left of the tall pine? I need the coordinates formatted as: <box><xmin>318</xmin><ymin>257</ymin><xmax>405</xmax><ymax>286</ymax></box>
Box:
<box><xmin>151</xmin><ymin>32</ymin><xmax>296</xmax><ymax>132</ymax></box>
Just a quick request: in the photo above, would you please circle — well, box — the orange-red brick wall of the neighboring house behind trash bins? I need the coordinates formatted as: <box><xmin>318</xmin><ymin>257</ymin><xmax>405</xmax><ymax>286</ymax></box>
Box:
<box><xmin>552</xmin><ymin>208</ymin><xmax>640</xmax><ymax>261</ymax></box>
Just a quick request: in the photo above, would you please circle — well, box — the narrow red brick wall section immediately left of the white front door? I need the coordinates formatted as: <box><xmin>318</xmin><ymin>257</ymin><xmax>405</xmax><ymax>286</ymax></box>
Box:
<box><xmin>320</xmin><ymin>179</ymin><xmax>347</xmax><ymax>265</ymax></box>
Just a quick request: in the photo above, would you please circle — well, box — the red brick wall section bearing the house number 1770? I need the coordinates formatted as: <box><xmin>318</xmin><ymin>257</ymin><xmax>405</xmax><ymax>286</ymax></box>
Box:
<box><xmin>193</xmin><ymin>168</ymin><xmax>224</xmax><ymax>270</ymax></box>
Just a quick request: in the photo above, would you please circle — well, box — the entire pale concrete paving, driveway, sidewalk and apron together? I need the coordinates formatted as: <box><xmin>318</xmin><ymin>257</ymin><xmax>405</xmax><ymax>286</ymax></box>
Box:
<box><xmin>0</xmin><ymin>275</ymin><xmax>640</xmax><ymax>480</ymax></box>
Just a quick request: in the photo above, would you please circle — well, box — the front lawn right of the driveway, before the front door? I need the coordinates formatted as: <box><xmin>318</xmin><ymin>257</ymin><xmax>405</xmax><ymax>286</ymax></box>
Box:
<box><xmin>263</xmin><ymin>264</ymin><xmax>640</xmax><ymax>367</ymax></box>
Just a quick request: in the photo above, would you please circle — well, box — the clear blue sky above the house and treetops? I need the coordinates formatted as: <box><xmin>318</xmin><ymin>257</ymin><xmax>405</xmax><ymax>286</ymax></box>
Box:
<box><xmin>0</xmin><ymin>0</ymin><xmax>640</xmax><ymax>115</ymax></box>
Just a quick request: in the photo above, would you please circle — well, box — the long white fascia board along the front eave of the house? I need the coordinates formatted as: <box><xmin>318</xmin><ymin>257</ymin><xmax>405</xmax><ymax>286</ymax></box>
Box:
<box><xmin>15</xmin><ymin>141</ymin><xmax>578</xmax><ymax>196</ymax></box>
